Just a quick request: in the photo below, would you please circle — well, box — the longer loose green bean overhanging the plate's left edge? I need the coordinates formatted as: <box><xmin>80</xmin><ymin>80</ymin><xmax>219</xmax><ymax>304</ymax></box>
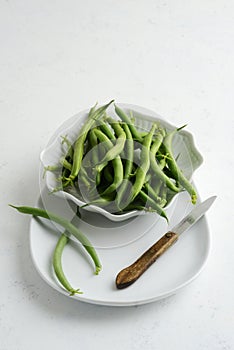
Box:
<box><xmin>10</xmin><ymin>204</ymin><xmax>101</xmax><ymax>274</ymax></box>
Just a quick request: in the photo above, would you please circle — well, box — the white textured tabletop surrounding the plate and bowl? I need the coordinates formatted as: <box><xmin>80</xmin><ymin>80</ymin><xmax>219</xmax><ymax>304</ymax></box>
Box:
<box><xmin>0</xmin><ymin>0</ymin><xmax>234</xmax><ymax>350</ymax></box>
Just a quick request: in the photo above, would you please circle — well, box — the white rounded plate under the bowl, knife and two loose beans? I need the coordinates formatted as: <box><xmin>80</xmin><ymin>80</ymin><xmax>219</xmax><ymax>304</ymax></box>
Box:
<box><xmin>30</xmin><ymin>187</ymin><xmax>210</xmax><ymax>306</ymax></box>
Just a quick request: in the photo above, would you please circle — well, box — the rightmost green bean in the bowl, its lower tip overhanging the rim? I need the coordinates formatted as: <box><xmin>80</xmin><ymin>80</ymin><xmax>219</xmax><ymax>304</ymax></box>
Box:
<box><xmin>163</xmin><ymin>125</ymin><xmax>197</xmax><ymax>204</ymax></box>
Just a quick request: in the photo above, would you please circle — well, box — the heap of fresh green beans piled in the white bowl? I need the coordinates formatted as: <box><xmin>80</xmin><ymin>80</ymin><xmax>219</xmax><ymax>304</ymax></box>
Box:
<box><xmin>46</xmin><ymin>101</ymin><xmax>197</xmax><ymax>220</ymax></box>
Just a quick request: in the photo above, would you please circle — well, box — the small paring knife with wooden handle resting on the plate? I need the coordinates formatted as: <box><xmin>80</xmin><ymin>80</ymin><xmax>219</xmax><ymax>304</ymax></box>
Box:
<box><xmin>116</xmin><ymin>196</ymin><xmax>216</xmax><ymax>289</ymax></box>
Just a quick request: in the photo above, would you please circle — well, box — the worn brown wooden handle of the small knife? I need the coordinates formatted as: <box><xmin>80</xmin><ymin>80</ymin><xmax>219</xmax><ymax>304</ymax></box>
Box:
<box><xmin>115</xmin><ymin>231</ymin><xmax>178</xmax><ymax>289</ymax></box>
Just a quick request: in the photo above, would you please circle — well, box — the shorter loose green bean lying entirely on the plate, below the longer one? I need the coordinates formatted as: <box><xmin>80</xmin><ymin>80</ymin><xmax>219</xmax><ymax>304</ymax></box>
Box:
<box><xmin>53</xmin><ymin>231</ymin><xmax>82</xmax><ymax>296</ymax></box>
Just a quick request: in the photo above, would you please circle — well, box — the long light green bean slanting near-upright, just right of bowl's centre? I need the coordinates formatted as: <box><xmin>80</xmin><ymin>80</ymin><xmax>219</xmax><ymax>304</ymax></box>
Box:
<box><xmin>130</xmin><ymin>124</ymin><xmax>156</xmax><ymax>201</ymax></box>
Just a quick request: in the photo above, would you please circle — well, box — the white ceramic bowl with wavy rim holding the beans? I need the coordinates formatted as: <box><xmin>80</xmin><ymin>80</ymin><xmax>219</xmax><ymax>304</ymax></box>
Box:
<box><xmin>40</xmin><ymin>103</ymin><xmax>203</xmax><ymax>221</ymax></box>
